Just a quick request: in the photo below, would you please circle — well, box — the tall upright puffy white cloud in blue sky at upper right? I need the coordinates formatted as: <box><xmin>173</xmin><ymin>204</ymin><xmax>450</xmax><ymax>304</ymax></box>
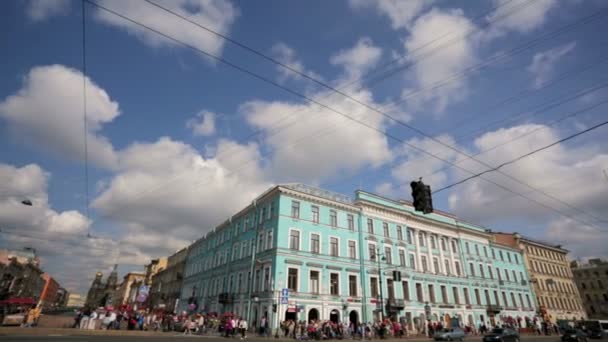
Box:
<box><xmin>403</xmin><ymin>9</ymin><xmax>478</xmax><ymax>112</ymax></box>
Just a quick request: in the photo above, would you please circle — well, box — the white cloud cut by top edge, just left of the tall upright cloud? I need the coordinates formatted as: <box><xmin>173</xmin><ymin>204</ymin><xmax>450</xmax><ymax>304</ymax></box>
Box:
<box><xmin>349</xmin><ymin>0</ymin><xmax>434</xmax><ymax>30</ymax></box>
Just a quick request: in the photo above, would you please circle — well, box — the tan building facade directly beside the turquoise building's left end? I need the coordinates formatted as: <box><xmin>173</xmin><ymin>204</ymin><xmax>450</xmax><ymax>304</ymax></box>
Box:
<box><xmin>150</xmin><ymin>248</ymin><xmax>189</xmax><ymax>311</ymax></box>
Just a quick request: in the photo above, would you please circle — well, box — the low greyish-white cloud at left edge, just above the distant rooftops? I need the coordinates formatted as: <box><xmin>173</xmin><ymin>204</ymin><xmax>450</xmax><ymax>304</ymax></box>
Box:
<box><xmin>0</xmin><ymin>164</ymin><xmax>117</xmax><ymax>293</ymax></box>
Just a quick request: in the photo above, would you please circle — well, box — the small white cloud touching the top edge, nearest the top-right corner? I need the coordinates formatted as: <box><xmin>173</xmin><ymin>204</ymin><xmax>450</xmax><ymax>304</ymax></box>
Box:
<box><xmin>485</xmin><ymin>0</ymin><xmax>559</xmax><ymax>39</ymax></box>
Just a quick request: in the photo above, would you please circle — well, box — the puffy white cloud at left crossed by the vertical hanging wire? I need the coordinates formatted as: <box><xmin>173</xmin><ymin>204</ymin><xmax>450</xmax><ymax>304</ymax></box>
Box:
<box><xmin>0</xmin><ymin>65</ymin><xmax>120</xmax><ymax>168</ymax></box>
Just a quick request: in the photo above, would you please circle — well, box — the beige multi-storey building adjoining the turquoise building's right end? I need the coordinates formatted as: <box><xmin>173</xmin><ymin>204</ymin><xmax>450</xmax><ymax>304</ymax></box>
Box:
<box><xmin>493</xmin><ymin>233</ymin><xmax>587</xmax><ymax>323</ymax></box>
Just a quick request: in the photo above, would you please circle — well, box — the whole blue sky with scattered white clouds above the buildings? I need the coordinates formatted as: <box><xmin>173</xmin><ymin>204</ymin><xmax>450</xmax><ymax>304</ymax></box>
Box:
<box><xmin>0</xmin><ymin>0</ymin><xmax>608</xmax><ymax>294</ymax></box>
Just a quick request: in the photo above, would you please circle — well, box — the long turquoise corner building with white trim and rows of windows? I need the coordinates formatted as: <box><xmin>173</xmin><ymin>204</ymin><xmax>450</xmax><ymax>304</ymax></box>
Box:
<box><xmin>180</xmin><ymin>184</ymin><xmax>536</xmax><ymax>330</ymax></box>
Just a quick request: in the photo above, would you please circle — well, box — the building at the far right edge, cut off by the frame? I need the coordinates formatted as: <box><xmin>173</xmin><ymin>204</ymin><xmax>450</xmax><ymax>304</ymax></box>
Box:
<box><xmin>571</xmin><ymin>259</ymin><xmax>608</xmax><ymax>319</ymax></box>
